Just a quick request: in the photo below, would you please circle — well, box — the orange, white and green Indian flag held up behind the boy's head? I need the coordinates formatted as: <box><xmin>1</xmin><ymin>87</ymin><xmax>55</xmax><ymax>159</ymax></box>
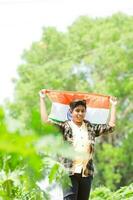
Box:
<box><xmin>42</xmin><ymin>90</ymin><xmax>110</xmax><ymax>124</ymax></box>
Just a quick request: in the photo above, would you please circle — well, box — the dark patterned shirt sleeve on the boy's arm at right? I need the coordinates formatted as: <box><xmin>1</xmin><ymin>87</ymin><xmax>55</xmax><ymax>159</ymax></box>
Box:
<box><xmin>92</xmin><ymin>124</ymin><xmax>115</xmax><ymax>137</ymax></box>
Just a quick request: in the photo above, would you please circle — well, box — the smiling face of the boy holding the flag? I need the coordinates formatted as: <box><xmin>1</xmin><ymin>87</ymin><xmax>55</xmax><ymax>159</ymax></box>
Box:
<box><xmin>71</xmin><ymin>105</ymin><xmax>86</xmax><ymax>123</ymax></box>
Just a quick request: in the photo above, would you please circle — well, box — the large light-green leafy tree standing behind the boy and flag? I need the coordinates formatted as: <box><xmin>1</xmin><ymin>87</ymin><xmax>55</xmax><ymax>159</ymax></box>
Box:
<box><xmin>9</xmin><ymin>13</ymin><xmax>133</xmax><ymax>191</ymax></box>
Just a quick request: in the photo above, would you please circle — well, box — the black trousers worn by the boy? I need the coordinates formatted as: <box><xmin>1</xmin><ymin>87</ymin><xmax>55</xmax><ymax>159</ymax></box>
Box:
<box><xmin>63</xmin><ymin>174</ymin><xmax>93</xmax><ymax>200</ymax></box>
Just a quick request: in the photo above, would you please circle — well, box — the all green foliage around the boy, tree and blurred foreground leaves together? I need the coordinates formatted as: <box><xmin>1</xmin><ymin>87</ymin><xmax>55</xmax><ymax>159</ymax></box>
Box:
<box><xmin>0</xmin><ymin>13</ymin><xmax>133</xmax><ymax>200</ymax></box>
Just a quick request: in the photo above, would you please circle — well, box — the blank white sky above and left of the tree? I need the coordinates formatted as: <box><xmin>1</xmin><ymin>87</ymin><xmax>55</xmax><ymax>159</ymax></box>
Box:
<box><xmin>0</xmin><ymin>0</ymin><xmax>133</xmax><ymax>104</ymax></box>
